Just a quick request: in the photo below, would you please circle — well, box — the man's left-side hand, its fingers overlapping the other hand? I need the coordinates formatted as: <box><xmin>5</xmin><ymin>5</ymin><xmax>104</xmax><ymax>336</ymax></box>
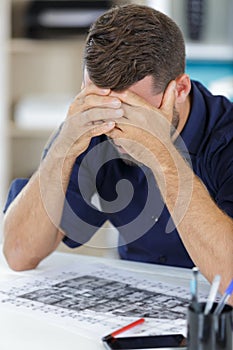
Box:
<box><xmin>56</xmin><ymin>84</ymin><xmax>124</xmax><ymax>158</ymax></box>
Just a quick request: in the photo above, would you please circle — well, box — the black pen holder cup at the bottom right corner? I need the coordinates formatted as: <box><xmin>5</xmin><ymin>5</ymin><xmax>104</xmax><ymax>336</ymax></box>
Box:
<box><xmin>187</xmin><ymin>303</ymin><xmax>233</xmax><ymax>350</ymax></box>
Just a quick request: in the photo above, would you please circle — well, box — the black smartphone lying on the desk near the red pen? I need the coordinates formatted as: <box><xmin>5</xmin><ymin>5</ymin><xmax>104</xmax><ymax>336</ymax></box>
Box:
<box><xmin>102</xmin><ymin>334</ymin><xmax>186</xmax><ymax>350</ymax></box>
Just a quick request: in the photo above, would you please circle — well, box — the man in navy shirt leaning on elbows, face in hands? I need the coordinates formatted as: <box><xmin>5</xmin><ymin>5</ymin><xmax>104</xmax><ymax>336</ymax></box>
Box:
<box><xmin>4</xmin><ymin>4</ymin><xmax>233</xmax><ymax>302</ymax></box>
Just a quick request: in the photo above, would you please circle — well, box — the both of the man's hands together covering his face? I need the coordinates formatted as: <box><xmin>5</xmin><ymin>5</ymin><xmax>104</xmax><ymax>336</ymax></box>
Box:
<box><xmin>56</xmin><ymin>81</ymin><xmax>175</xmax><ymax>165</ymax></box>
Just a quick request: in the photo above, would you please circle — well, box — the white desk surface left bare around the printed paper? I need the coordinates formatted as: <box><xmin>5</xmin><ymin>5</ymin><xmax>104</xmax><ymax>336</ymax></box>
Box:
<box><xmin>0</xmin><ymin>245</ymin><xmax>209</xmax><ymax>350</ymax></box>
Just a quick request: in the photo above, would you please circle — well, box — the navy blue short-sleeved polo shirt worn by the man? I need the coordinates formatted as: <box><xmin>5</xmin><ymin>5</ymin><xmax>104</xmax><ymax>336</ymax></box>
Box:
<box><xmin>3</xmin><ymin>82</ymin><xmax>233</xmax><ymax>267</ymax></box>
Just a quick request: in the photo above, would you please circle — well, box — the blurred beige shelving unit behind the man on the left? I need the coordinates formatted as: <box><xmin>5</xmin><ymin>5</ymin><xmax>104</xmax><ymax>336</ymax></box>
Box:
<box><xmin>8</xmin><ymin>0</ymin><xmax>88</xmax><ymax>186</ymax></box>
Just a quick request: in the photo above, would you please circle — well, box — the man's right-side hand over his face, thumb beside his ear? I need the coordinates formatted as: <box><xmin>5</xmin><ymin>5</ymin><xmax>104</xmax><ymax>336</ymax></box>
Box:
<box><xmin>107</xmin><ymin>81</ymin><xmax>176</xmax><ymax>166</ymax></box>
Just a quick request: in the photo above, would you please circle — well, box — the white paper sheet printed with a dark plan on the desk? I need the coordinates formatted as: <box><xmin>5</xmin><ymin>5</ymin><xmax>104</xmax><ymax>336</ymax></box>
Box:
<box><xmin>0</xmin><ymin>261</ymin><xmax>208</xmax><ymax>338</ymax></box>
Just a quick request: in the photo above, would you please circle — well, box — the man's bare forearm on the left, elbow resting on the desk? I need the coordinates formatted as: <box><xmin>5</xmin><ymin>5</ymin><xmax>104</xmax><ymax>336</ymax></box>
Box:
<box><xmin>3</xmin><ymin>152</ymin><xmax>73</xmax><ymax>270</ymax></box>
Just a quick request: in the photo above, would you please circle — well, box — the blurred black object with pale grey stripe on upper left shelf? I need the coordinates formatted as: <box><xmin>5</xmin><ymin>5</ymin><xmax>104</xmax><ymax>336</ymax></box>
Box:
<box><xmin>25</xmin><ymin>0</ymin><xmax>112</xmax><ymax>39</ymax></box>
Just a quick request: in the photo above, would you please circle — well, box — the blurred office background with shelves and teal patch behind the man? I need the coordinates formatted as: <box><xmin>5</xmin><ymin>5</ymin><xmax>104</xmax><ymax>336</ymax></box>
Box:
<box><xmin>0</xmin><ymin>0</ymin><xmax>233</xmax><ymax>255</ymax></box>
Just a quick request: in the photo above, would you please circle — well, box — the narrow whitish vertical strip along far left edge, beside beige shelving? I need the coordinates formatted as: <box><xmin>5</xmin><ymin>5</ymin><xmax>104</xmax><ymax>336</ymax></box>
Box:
<box><xmin>0</xmin><ymin>0</ymin><xmax>10</xmax><ymax>241</ymax></box>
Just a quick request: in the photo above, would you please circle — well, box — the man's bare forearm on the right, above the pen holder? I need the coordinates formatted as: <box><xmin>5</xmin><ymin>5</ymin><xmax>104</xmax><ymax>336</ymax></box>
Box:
<box><xmin>151</xmin><ymin>146</ymin><xmax>233</xmax><ymax>300</ymax></box>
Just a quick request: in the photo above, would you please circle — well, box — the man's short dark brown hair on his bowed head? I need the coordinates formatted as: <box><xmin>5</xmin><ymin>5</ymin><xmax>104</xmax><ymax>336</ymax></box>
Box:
<box><xmin>84</xmin><ymin>4</ymin><xmax>185</xmax><ymax>93</ymax></box>
